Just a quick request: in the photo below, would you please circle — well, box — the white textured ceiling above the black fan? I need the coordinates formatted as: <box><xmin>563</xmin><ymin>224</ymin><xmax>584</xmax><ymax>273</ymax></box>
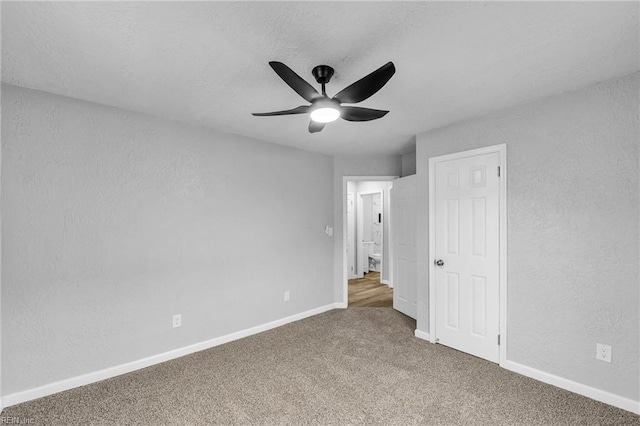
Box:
<box><xmin>2</xmin><ymin>2</ymin><xmax>640</xmax><ymax>154</ymax></box>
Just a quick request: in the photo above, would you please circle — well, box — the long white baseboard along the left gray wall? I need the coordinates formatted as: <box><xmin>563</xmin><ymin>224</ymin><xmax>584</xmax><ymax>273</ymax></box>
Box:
<box><xmin>2</xmin><ymin>303</ymin><xmax>341</xmax><ymax>408</ymax></box>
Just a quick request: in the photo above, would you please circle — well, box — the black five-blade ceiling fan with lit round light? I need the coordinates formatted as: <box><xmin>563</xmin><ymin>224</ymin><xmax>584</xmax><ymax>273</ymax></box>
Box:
<box><xmin>252</xmin><ymin>61</ymin><xmax>396</xmax><ymax>133</ymax></box>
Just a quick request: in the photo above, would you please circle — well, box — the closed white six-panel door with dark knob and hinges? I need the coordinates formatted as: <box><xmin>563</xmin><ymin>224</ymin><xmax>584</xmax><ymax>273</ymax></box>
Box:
<box><xmin>433</xmin><ymin>152</ymin><xmax>500</xmax><ymax>362</ymax></box>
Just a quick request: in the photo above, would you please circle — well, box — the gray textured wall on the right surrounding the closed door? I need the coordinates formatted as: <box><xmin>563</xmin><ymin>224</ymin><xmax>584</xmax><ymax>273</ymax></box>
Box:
<box><xmin>417</xmin><ymin>73</ymin><xmax>640</xmax><ymax>401</ymax></box>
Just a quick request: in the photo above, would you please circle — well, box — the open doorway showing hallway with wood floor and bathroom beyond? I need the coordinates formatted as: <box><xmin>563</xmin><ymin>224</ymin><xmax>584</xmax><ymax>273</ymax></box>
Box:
<box><xmin>343</xmin><ymin>176</ymin><xmax>397</xmax><ymax>307</ymax></box>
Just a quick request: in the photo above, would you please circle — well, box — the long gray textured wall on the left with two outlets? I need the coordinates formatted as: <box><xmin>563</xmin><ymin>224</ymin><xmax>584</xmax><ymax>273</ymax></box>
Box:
<box><xmin>2</xmin><ymin>86</ymin><xmax>334</xmax><ymax>395</ymax></box>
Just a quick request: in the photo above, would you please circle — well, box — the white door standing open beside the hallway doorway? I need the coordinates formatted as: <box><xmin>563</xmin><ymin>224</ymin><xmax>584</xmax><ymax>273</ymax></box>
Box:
<box><xmin>390</xmin><ymin>175</ymin><xmax>418</xmax><ymax>319</ymax></box>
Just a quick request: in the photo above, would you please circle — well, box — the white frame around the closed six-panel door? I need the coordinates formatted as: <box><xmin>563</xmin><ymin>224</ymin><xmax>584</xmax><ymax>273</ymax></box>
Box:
<box><xmin>428</xmin><ymin>144</ymin><xmax>507</xmax><ymax>367</ymax></box>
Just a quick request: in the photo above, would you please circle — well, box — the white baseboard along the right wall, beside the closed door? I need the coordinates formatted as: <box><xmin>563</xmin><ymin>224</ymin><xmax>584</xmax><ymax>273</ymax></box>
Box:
<box><xmin>504</xmin><ymin>358</ymin><xmax>640</xmax><ymax>414</ymax></box>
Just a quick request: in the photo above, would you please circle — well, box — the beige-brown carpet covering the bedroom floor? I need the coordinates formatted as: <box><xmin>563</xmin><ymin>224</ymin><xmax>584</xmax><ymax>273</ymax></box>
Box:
<box><xmin>2</xmin><ymin>308</ymin><xmax>640</xmax><ymax>425</ymax></box>
